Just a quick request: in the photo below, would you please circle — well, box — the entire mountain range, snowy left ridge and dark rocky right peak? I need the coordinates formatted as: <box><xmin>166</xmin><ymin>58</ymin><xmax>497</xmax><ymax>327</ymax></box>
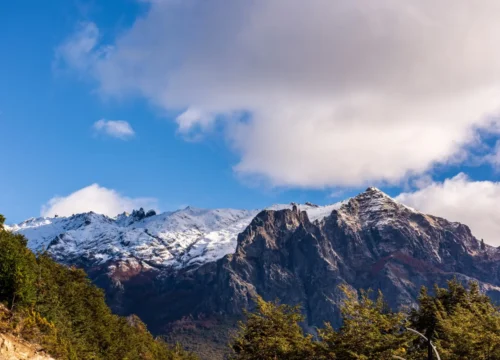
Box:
<box><xmin>10</xmin><ymin>188</ymin><xmax>500</xmax><ymax>358</ymax></box>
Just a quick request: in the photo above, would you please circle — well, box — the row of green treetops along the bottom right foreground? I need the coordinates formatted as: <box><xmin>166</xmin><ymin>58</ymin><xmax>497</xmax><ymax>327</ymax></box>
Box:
<box><xmin>231</xmin><ymin>280</ymin><xmax>500</xmax><ymax>360</ymax></box>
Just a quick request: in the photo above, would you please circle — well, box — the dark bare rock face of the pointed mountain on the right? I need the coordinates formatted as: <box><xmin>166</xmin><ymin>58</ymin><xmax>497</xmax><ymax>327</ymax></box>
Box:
<box><xmin>114</xmin><ymin>188</ymin><xmax>500</xmax><ymax>333</ymax></box>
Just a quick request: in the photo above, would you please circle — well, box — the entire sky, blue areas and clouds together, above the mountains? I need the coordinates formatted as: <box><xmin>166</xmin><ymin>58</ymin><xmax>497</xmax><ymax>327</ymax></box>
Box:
<box><xmin>0</xmin><ymin>0</ymin><xmax>500</xmax><ymax>245</ymax></box>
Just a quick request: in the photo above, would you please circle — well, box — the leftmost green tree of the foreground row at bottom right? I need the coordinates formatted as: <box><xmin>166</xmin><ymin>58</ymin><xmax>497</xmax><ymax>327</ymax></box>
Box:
<box><xmin>231</xmin><ymin>297</ymin><xmax>316</xmax><ymax>360</ymax></box>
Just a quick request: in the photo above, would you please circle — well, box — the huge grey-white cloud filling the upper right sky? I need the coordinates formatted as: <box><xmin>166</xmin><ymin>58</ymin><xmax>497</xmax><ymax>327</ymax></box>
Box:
<box><xmin>60</xmin><ymin>0</ymin><xmax>500</xmax><ymax>187</ymax></box>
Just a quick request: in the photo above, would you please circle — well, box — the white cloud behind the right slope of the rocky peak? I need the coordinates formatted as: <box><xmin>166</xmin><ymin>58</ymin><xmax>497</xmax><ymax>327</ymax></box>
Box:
<box><xmin>396</xmin><ymin>173</ymin><xmax>500</xmax><ymax>246</ymax></box>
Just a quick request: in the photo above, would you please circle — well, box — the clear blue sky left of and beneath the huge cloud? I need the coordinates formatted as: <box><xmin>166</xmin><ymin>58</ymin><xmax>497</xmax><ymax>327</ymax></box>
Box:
<box><xmin>0</xmin><ymin>0</ymin><xmax>362</xmax><ymax>222</ymax></box>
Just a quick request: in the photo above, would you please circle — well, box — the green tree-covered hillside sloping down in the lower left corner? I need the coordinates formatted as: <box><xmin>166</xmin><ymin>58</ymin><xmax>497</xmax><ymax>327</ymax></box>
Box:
<box><xmin>0</xmin><ymin>216</ymin><xmax>195</xmax><ymax>360</ymax></box>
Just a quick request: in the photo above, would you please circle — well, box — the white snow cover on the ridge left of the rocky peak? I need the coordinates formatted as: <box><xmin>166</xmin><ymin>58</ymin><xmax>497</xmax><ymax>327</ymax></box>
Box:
<box><xmin>10</xmin><ymin>203</ymin><xmax>340</xmax><ymax>270</ymax></box>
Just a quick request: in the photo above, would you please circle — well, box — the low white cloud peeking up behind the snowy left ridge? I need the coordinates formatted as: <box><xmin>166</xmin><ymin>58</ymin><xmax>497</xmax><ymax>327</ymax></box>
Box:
<box><xmin>41</xmin><ymin>184</ymin><xmax>158</xmax><ymax>216</ymax></box>
